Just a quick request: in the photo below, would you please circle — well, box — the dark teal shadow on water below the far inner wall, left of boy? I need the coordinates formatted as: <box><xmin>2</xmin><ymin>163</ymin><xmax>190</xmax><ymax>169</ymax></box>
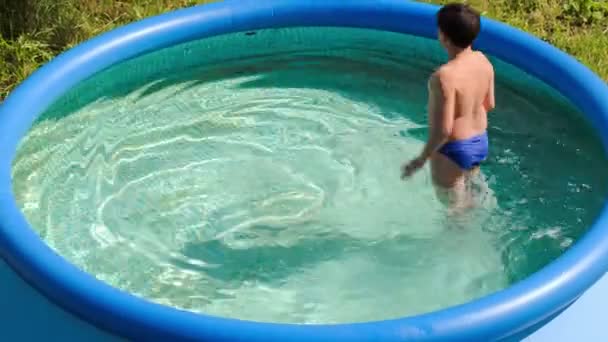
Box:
<box><xmin>39</xmin><ymin>52</ymin><xmax>430</xmax><ymax>130</ymax></box>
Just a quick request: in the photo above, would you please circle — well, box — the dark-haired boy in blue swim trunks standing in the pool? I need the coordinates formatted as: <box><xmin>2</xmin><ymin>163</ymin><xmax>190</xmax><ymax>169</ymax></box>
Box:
<box><xmin>402</xmin><ymin>4</ymin><xmax>495</xmax><ymax>207</ymax></box>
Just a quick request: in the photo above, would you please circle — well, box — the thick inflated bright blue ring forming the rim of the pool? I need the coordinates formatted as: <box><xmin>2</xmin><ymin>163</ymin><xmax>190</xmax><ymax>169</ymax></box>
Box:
<box><xmin>0</xmin><ymin>0</ymin><xmax>608</xmax><ymax>342</ymax></box>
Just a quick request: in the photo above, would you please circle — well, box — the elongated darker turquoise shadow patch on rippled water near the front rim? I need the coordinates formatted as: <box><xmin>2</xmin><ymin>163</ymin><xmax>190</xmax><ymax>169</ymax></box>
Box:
<box><xmin>173</xmin><ymin>226</ymin><xmax>434</xmax><ymax>286</ymax></box>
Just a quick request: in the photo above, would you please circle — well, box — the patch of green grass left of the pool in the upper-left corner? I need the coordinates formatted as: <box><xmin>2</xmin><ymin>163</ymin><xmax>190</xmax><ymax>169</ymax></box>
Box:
<box><xmin>0</xmin><ymin>0</ymin><xmax>211</xmax><ymax>102</ymax></box>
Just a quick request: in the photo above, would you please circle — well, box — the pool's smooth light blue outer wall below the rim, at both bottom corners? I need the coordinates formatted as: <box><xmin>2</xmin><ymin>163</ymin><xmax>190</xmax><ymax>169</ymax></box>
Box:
<box><xmin>0</xmin><ymin>255</ymin><xmax>608</xmax><ymax>342</ymax></box>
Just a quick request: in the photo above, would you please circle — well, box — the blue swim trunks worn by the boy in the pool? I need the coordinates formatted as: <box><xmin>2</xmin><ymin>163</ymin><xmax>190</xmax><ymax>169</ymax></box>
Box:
<box><xmin>439</xmin><ymin>132</ymin><xmax>489</xmax><ymax>171</ymax></box>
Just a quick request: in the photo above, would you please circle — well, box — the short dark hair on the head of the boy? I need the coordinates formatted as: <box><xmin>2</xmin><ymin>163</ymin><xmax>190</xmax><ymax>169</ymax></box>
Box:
<box><xmin>437</xmin><ymin>4</ymin><xmax>481</xmax><ymax>49</ymax></box>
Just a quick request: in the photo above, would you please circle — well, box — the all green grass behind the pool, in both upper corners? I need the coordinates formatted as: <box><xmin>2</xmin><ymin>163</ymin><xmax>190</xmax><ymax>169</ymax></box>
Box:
<box><xmin>0</xmin><ymin>0</ymin><xmax>608</xmax><ymax>102</ymax></box>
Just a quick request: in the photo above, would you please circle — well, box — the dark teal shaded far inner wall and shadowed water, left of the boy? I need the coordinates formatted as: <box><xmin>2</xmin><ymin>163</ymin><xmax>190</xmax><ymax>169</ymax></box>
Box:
<box><xmin>39</xmin><ymin>28</ymin><xmax>443</xmax><ymax>135</ymax></box>
